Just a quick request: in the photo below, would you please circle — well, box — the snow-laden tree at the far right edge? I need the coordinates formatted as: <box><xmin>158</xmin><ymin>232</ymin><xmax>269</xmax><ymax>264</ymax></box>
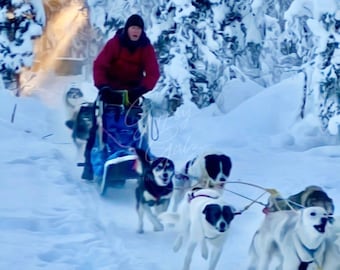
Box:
<box><xmin>286</xmin><ymin>0</ymin><xmax>340</xmax><ymax>135</ymax></box>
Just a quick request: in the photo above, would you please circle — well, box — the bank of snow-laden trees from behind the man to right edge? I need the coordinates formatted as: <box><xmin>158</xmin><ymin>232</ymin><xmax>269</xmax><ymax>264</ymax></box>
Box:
<box><xmin>83</xmin><ymin>0</ymin><xmax>340</xmax><ymax>138</ymax></box>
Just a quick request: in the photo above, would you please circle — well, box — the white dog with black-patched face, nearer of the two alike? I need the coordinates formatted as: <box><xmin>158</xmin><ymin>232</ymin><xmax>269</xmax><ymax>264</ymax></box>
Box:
<box><xmin>160</xmin><ymin>188</ymin><xmax>236</xmax><ymax>270</ymax></box>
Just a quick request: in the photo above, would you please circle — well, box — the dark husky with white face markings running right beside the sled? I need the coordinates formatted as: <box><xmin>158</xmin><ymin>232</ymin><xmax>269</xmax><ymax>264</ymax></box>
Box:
<box><xmin>136</xmin><ymin>149</ymin><xmax>175</xmax><ymax>233</ymax></box>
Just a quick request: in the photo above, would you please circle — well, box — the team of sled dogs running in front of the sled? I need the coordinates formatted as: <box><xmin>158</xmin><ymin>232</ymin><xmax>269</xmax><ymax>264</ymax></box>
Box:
<box><xmin>136</xmin><ymin>149</ymin><xmax>340</xmax><ymax>270</ymax></box>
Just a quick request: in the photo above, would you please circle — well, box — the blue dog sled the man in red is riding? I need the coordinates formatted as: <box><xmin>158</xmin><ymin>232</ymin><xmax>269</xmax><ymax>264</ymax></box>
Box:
<box><xmin>80</xmin><ymin>90</ymin><xmax>149</xmax><ymax>195</ymax></box>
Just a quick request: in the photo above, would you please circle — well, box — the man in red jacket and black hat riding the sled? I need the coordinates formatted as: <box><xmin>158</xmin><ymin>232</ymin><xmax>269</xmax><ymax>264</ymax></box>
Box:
<box><xmin>82</xmin><ymin>14</ymin><xmax>160</xmax><ymax>180</ymax></box>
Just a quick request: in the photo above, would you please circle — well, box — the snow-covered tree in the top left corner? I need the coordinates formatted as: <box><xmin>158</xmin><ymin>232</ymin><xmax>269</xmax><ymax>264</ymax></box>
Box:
<box><xmin>0</xmin><ymin>0</ymin><xmax>45</xmax><ymax>93</ymax></box>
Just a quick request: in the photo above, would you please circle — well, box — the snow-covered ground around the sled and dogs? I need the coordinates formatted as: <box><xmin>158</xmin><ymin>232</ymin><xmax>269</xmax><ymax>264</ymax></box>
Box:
<box><xmin>0</xmin><ymin>68</ymin><xmax>340</xmax><ymax>270</ymax></box>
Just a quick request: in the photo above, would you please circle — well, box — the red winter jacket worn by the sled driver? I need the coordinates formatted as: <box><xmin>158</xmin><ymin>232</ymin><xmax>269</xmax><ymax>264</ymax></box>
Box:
<box><xmin>93</xmin><ymin>29</ymin><xmax>160</xmax><ymax>92</ymax></box>
